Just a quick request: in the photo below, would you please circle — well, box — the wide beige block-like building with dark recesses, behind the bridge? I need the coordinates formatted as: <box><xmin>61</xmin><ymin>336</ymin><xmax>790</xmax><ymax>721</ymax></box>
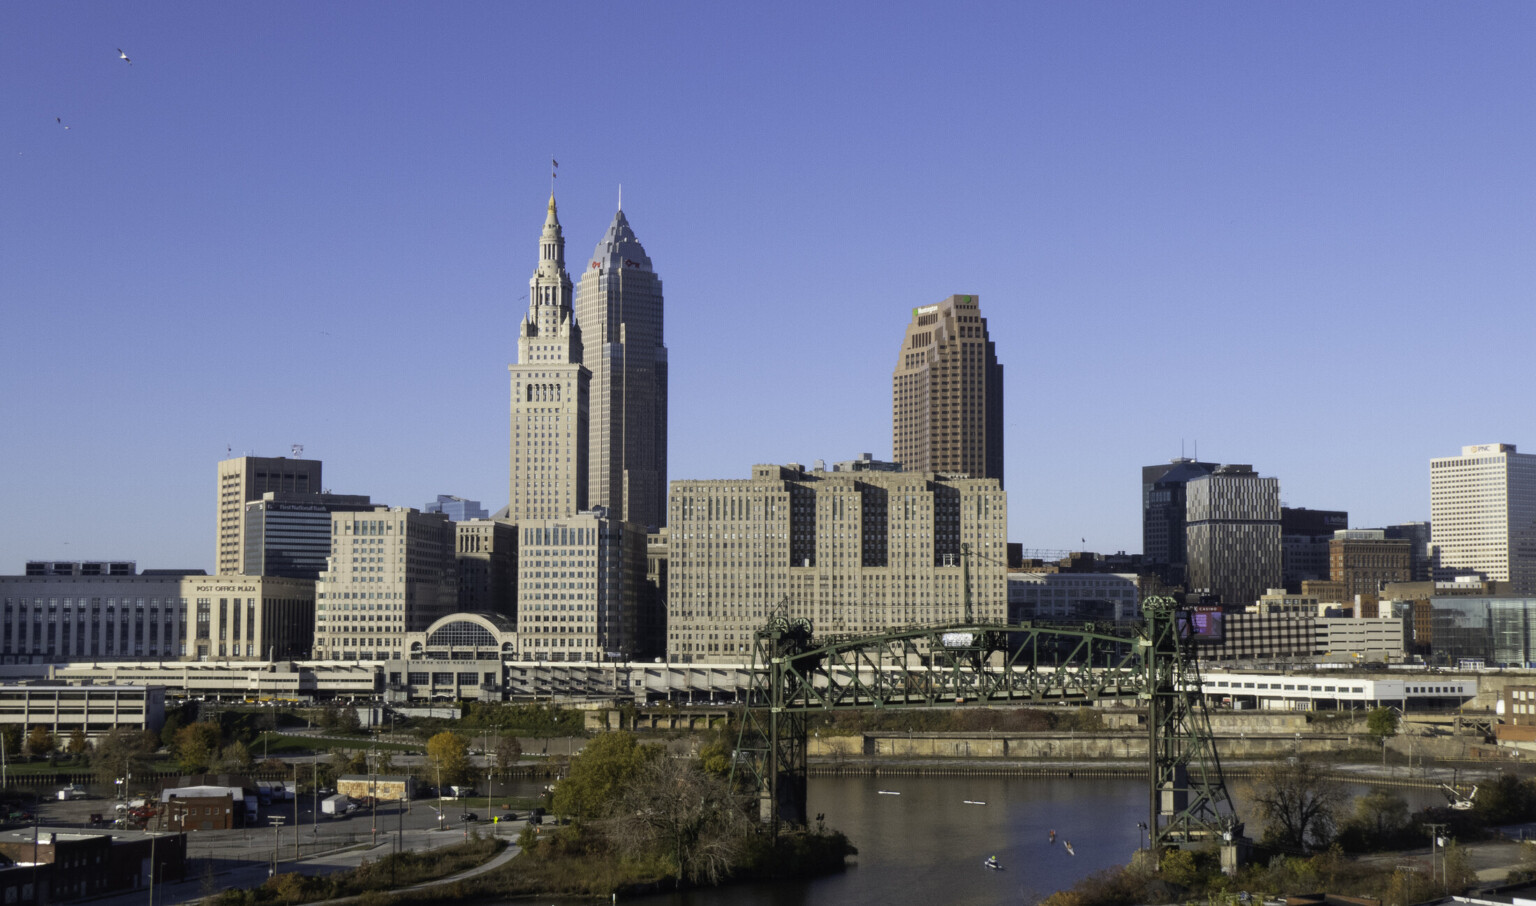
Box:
<box><xmin>667</xmin><ymin>464</ymin><xmax>1008</xmax><ymax>663</ymax></box>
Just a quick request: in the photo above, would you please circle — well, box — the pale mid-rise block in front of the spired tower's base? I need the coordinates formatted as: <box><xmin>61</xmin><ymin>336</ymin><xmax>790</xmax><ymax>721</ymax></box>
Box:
<box><xmin>518</xmin><ymin>508</ymin><xmax>647</xmax><ymax>662</ymax></box>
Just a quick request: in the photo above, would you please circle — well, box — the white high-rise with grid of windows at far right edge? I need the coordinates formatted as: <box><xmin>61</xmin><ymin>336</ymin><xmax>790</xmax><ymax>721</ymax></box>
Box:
<box><xmin>1430</xmin><ymin>444</ymin><xmax>1536</xmax><ymax>594</ymax></box>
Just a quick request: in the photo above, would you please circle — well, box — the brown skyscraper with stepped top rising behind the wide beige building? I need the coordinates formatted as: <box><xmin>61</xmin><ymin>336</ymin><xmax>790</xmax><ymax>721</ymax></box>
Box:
<box><xmin>891</xmin><ymin>296</ymin><xmax>1003</xmax><ymax>482</ymax></box>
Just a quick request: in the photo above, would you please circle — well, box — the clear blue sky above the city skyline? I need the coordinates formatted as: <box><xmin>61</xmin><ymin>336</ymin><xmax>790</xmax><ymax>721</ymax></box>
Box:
<box><xmin>0</xmin><ymin>0</ymin><xmax>1536</xmax><ymax>573</ymax></box>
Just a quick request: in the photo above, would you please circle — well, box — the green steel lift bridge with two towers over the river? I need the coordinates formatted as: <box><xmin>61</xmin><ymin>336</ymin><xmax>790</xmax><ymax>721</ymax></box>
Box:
<box><xmin>736</xmin><ymin>597</ymin><xmax>1243</xmax><ymax>849</ymax></box>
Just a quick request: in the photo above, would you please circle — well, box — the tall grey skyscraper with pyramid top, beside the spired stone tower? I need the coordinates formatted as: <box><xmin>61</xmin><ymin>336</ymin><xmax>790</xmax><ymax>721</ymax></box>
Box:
<box><xmin>576</xmin><ymin>207</ymin><xmax>667</xmax><ymax>528</ymax></box>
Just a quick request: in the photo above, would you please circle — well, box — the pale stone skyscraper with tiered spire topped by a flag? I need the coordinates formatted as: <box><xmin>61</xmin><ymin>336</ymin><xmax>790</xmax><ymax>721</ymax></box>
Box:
<box><xmin>507</xmin><ymin>193</ymin><xmax>591</xmax><ymax>522</ymax></box>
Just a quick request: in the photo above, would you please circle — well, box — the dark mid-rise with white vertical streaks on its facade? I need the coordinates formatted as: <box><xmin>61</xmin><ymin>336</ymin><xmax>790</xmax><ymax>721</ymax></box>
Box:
<box><xmin>1186</xmin><ymin>465</ymin><xmax>1281</xmax><ymax>605</ymax></box>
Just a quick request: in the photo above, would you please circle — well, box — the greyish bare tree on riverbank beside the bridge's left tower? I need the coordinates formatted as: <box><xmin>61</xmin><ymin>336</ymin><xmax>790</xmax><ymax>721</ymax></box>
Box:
<box><xmin>608</xmin><ymin>757</ymin><xmax>751</xmax><ymax>885</ymax></box>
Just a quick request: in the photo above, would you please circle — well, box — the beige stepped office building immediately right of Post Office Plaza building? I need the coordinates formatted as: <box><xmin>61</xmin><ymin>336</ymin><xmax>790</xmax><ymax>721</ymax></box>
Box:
<box><xmin>313</xmin><ymin>507</ymin><xmax>459</xmax><ymax>660</ymax></box>
